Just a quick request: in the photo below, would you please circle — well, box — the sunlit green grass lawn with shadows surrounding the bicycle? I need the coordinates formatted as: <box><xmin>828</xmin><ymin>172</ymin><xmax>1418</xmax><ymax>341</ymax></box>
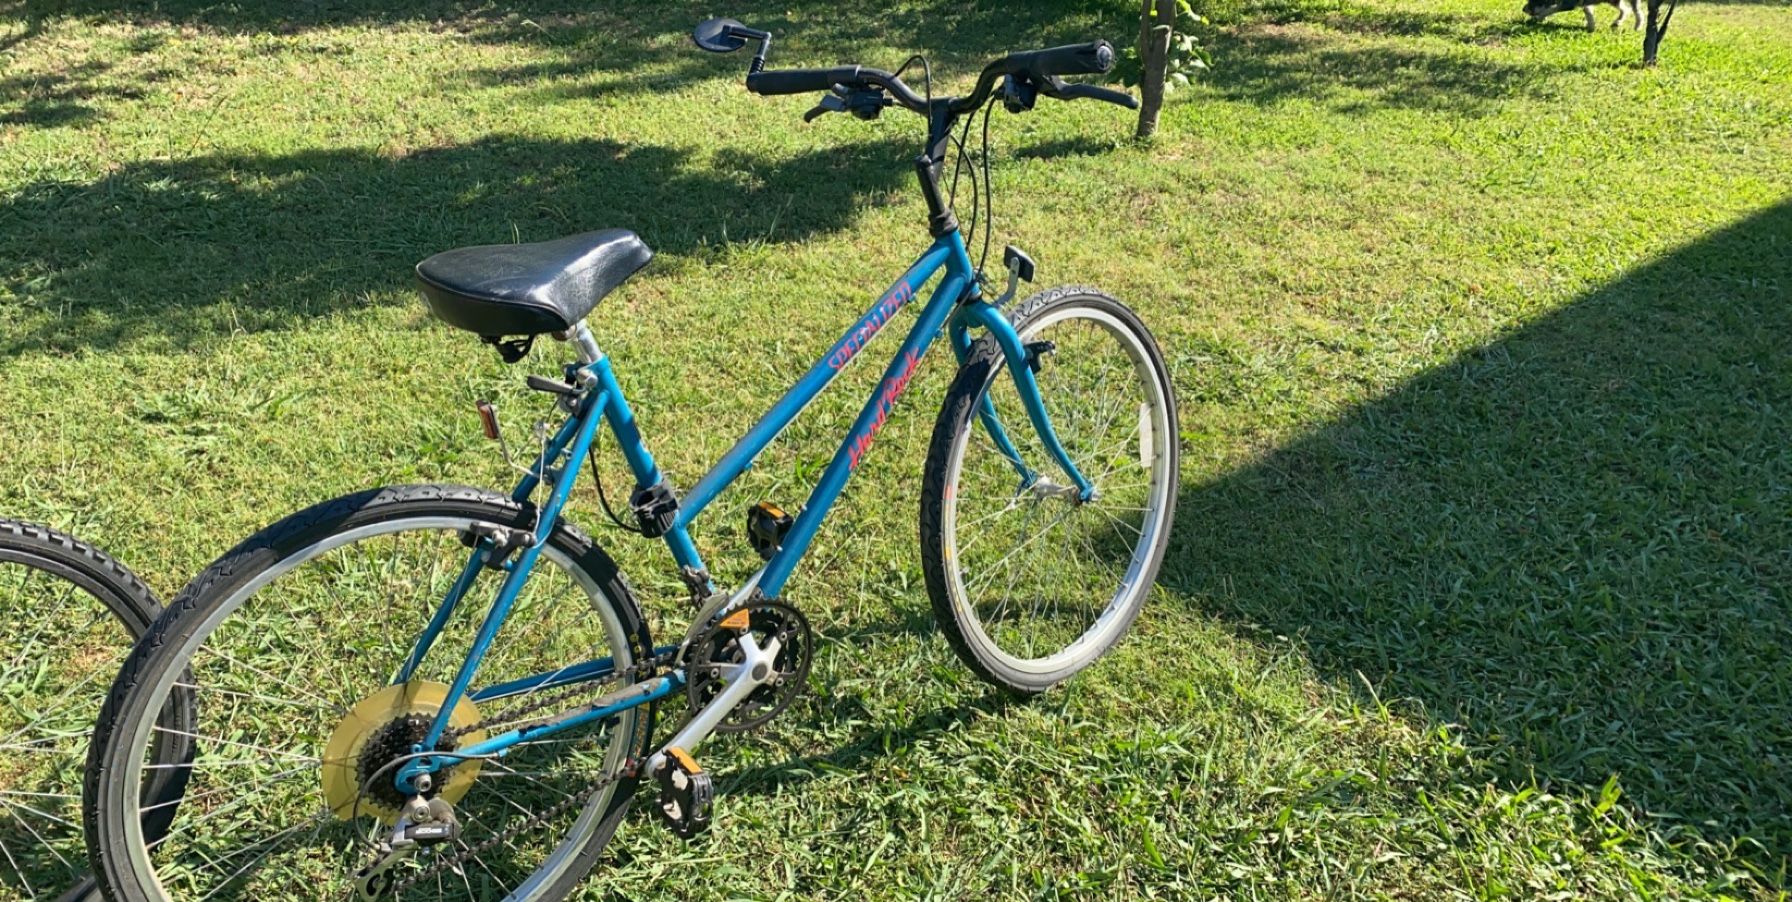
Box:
<box><xmin>0</xmin><ymin>0</ymin><xmax>1792</xmax><ymax>898</ymax></box>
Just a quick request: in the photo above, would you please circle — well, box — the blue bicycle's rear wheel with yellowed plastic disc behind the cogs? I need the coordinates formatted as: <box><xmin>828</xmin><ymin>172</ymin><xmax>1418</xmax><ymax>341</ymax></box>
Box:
<box><xmin>86</xmin><ymin>486</ymin><xmax>652</xmax><ymax>900</ymax></box>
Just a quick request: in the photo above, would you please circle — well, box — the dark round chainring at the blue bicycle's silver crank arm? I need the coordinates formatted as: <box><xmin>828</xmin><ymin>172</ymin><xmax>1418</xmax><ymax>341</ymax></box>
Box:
<box><xmin>685</xmin><ymin>601</ymin><xmax>815</xmax><ymax>733</ymax></box>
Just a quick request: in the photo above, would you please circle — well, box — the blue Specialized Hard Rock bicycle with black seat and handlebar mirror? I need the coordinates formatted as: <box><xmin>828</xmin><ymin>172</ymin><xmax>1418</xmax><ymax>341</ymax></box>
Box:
<box><xmin>86</xmin><ymin>20</ymin><xmax>1177</xmax><ymax>900</ymax></box>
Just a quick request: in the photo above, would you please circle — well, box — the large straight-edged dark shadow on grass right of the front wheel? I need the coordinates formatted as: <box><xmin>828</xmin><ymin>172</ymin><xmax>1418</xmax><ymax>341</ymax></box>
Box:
<box><xmin>1161</xmin><ymin>201</ymin><xmax>1792</xmax><ymax>875</ymax></box>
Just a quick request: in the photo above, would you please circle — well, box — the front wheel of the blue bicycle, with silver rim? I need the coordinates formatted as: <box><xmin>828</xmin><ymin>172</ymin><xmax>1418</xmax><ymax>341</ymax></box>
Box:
<box><xmin>921</xmin><ymin>287</ymin><xmax>1177</xmax><ymax>694</ymax></box>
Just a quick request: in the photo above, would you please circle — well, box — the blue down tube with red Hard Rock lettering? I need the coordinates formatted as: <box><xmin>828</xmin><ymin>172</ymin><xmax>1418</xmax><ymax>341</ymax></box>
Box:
<box><xmin>760</xmin><ymin>268</ymin><xmax>968</xmax><ymax>597</ymax></box>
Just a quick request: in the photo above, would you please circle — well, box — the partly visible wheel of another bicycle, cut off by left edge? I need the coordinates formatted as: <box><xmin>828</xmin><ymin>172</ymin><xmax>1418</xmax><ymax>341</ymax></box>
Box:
<box><xmin>0</xmin><ymin>520</ymin><xmax>190</xmax><ymax>898</ymax></box>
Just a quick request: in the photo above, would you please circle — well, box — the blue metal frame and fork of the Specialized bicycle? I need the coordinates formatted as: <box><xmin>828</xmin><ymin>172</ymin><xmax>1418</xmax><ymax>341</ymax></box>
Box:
<box><xmin>394</xmin><ymin>230</ymin><xmax>1095</xmax><ymax>793</ymax></box>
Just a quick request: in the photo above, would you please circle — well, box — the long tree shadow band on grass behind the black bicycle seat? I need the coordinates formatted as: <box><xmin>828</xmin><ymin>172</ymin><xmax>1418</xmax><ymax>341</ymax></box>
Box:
<box><xmin>0</xmin><ymin>138</ymin><xmax>914</xmax><ymax>353</ymax></box>
